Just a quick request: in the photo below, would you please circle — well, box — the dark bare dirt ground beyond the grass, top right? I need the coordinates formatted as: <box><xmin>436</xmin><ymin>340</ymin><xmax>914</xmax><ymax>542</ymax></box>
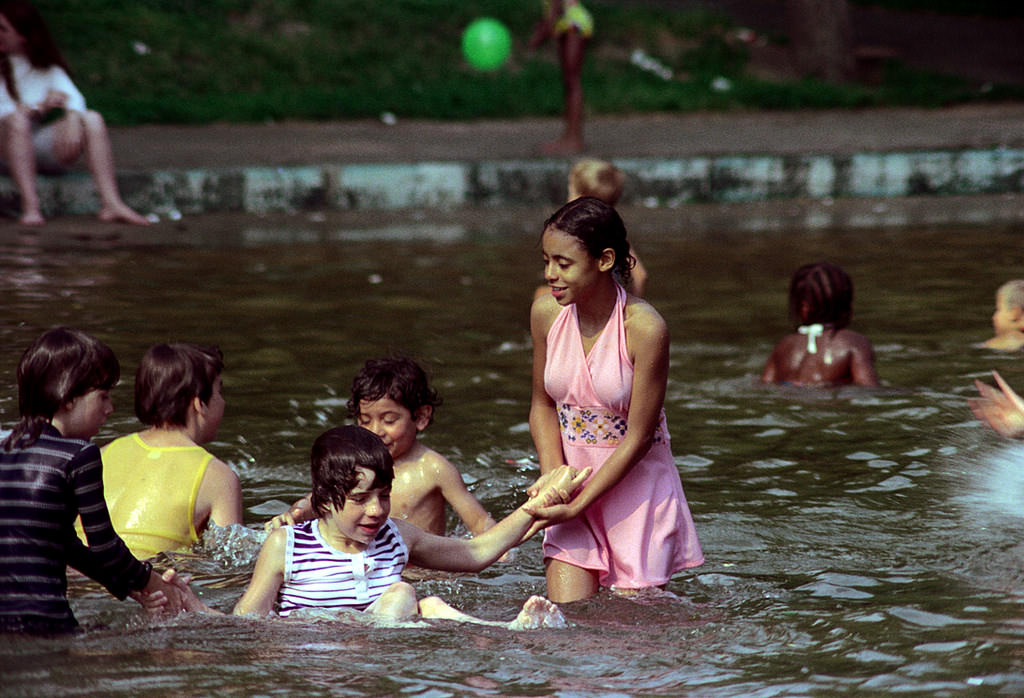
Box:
<box><xmin>631</xmin><ymin>0</ymin><xmax>1024</xmax><ymax>85</ymax></box>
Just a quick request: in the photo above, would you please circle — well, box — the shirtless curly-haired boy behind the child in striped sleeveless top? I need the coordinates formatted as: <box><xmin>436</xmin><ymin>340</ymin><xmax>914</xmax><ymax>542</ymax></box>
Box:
<box><xmin>266</xmin><ymin>357</ymin><xmax>495</xmax><ymax>535</ymax></box>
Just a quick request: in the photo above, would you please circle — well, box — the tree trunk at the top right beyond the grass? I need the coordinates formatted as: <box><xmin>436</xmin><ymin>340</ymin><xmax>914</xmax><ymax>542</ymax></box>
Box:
<box><xmin>785</xmin><ymin>0</ymin><xmax>855</xmax><ymax>82</ymax></box>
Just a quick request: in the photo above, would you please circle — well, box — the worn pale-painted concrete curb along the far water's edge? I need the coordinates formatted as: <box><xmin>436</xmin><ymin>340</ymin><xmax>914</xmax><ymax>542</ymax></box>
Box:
<box><xmin>0</xmin><ymin>142</ymin><xmax>1024</xmax><ymax>219</ymax></box>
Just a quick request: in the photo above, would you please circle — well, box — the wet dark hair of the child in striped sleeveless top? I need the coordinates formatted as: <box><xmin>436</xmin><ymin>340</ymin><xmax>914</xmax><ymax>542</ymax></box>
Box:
<box><xmin>309</xmin><ymin>425</ymin><xmax>394</xmax><ymax>517</ymax></box>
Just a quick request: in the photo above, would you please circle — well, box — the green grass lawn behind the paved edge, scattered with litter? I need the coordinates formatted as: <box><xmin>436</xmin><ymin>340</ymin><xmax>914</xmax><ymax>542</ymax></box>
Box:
<box><xmin>37</xmin><ymin>0</ymin><xmax>1024</xmax><ymax>124</ymax></box>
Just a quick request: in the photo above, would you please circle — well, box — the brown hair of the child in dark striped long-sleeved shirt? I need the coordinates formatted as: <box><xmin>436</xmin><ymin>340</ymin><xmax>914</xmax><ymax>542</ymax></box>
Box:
<box><xmin>3</xmin><ymin>328</ymin><xmax>121</xmax><ymax>451</ymax></box>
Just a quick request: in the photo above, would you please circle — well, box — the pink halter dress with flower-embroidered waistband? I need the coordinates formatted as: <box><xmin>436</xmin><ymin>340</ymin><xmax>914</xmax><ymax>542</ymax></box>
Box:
<box><xmin>544</xmin><ymin>287</ymin><xmax>703</xmax><ymax>588</ymax></box>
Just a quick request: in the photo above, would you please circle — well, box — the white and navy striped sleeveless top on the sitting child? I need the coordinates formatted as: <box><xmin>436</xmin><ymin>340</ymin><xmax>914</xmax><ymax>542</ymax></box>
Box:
<box><xmin>278</xmin><ymin>519</ymin><xmax>409</xmax><ymax>616</ymax></box>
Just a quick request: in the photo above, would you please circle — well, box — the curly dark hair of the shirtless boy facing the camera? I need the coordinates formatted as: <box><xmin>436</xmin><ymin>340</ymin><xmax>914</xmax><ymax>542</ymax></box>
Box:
<box><xmin>348</xmin><ymin>356</ymin><xmax>441</xmax><ymax>424</ymax></box>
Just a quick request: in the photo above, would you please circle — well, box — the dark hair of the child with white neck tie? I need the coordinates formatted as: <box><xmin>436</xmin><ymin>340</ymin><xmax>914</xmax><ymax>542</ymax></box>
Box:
<box><xmin>790</xmin><ymin>262</ymin><xmax>853</xmax><ymax>330</ymax></box>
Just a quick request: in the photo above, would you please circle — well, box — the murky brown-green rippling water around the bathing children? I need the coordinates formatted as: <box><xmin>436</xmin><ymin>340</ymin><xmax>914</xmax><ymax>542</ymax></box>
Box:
<box><xmin>0</xmin><ymin>210</ymin><xmax>1024</xmax><ymax>697</ymax></box>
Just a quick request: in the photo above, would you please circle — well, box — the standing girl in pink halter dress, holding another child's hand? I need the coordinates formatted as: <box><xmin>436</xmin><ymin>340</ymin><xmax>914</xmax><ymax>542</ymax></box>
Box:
<box><xmin>529</xmin><ymin>198</ymin><xmax>703</xmax><ymax>603</ymax></box>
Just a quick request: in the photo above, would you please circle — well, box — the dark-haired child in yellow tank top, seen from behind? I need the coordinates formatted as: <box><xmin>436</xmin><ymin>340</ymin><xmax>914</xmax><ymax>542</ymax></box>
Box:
<box><xmin>96</xmin><ymin>344</ymin><xmax>242</xmax><ymax>558</ymax></box>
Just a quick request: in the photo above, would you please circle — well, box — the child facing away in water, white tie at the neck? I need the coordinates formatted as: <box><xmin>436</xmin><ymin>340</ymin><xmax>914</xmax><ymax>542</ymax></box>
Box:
<box><xmin>761</xmin><ymin>262</ymin><xmax>879</xmax><ymax>386</ymax></box>
